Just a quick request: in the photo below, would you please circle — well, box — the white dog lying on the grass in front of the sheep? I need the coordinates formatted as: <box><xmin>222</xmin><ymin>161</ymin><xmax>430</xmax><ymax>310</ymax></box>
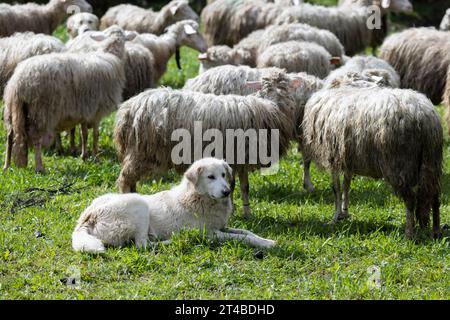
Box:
<box><xmin>72</xmin><ymin>158</ymin><xmax>275</xmax><ymax>253</ymax></box>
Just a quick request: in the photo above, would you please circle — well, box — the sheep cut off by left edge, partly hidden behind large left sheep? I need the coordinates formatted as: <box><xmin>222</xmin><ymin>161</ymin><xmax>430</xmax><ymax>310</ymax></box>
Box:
<box><xmin>0</xmin><ymin>32</ymin><xmax>65</xmax><ymax>95</ymax></box>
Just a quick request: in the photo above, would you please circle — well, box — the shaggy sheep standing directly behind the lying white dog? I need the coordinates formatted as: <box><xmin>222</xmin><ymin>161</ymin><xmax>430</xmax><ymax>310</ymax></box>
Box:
<box><xmin>114</xmin><ymin>72</ymin><xmax>298</xmax><ymax>215</ymax></box>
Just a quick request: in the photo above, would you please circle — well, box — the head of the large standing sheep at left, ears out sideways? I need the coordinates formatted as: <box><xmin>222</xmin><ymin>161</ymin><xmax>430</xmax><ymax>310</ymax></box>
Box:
<box><xmin>90</xmin><ymin>25</ymin><xmax>137</xmax><ymax>59</ymax></box>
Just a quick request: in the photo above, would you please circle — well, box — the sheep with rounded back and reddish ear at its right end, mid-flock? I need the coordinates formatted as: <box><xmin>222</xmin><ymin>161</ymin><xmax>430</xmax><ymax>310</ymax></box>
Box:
<box><xmin>256</xmin><ymin>41</ymin><xmax>340</xmax><ymax>78</ymax></box>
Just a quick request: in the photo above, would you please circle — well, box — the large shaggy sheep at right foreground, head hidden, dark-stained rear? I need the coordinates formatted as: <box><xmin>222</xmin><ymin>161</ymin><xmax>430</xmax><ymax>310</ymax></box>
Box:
<box><xmin>302</xmin><ymin>74</ymin><xmax>443</xmax><ymax>238</ymax></box>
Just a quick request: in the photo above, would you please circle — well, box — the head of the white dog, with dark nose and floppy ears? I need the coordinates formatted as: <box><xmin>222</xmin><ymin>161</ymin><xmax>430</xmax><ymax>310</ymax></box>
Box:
<box><xmin>184</xmin><ymin>158</ymin><xmax>233</xmax><ymax>199</ymax></box>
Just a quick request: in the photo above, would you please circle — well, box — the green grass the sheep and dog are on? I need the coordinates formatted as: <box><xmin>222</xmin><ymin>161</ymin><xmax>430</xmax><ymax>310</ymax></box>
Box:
<box><xmin>0</xmin><ymin>25</ymin><xmax>450</xmax><ymax>299</ymax></box>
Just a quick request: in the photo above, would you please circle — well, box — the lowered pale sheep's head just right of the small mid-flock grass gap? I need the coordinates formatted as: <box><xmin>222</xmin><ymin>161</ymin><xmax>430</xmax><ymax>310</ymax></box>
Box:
<box><xmin>198</xmin><ymin>45</ymin><xmax>251</xmax><ymax>71</ymax></box>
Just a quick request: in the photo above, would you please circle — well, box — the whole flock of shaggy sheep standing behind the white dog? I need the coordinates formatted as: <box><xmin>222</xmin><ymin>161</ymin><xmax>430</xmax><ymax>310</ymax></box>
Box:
<box><xmin>0</xmin><ymin>0</ymin><xmax>450</xmax><ymax>238</ymax></box>
